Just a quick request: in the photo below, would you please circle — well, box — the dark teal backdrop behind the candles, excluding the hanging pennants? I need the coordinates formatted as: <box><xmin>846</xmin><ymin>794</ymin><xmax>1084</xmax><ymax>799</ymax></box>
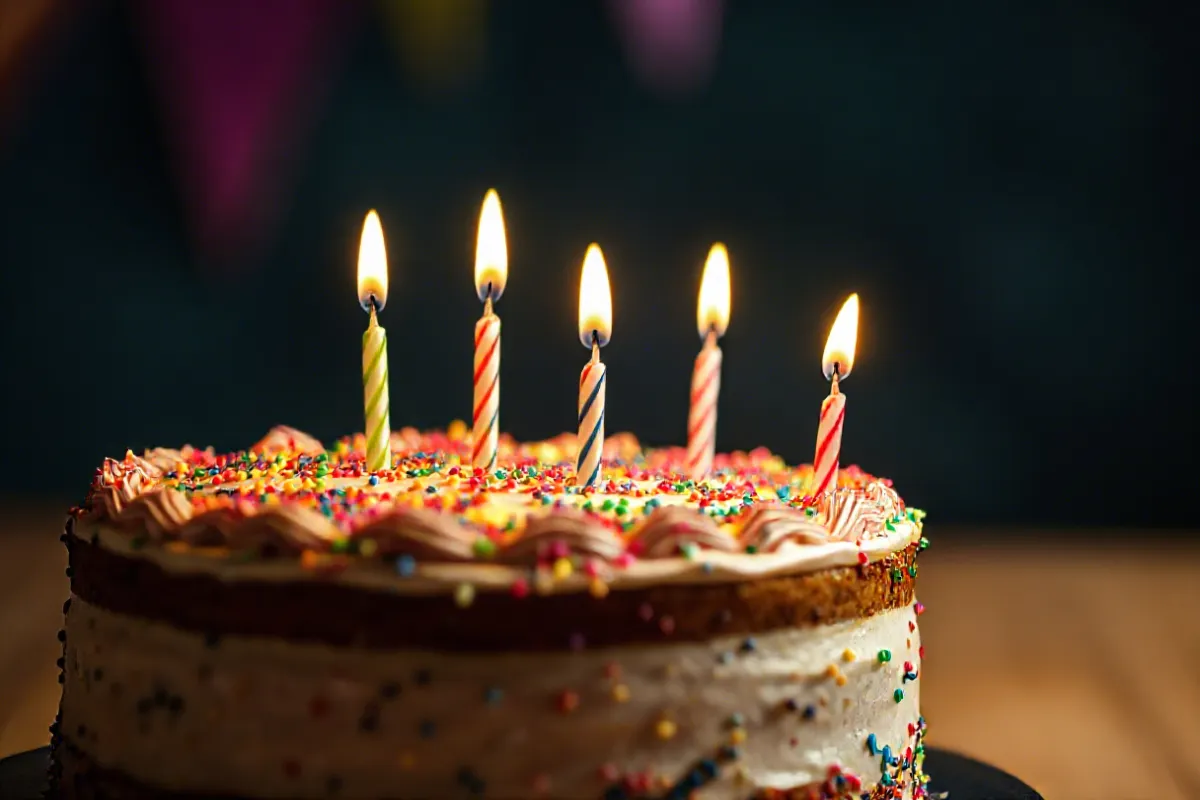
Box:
<box><xmin>0</xmin><ymin>0</ymin><xmax>1200</xmax><ymax>525</ymax></box>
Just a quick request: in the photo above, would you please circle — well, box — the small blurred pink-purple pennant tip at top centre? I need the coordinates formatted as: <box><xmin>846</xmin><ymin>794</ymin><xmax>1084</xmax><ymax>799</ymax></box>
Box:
<box><xmin>610</xmin><ymin>0</ymin><xmax>724</xmax><ymax>94</ymax></box>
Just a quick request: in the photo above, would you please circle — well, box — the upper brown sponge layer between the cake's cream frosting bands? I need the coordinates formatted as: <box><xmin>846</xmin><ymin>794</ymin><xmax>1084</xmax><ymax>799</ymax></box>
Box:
<box><xmin>67</xmin><ymin>534</ymin><xmax>918</xmax><ymax>651</ymax></box>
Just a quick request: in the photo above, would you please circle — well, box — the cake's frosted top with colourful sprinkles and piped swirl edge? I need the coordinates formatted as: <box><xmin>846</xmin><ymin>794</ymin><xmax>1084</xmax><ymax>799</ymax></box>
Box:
<box><xmin>76</xmin><ymin>422</ymin><xmax>923</xmax><ymax>594</ymax></box>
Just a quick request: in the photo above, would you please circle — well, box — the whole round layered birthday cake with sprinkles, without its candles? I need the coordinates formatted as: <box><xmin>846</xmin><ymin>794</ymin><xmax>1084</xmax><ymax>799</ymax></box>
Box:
<box><xmin>52</xmin><ymin>423</ymin><xmax>926</xmax><ymax>799</ymax></box>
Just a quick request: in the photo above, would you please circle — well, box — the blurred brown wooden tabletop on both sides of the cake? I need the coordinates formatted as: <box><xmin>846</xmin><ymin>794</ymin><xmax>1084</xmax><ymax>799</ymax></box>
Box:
<box><xmin>0</xmin><ymin>506</ymin><xmax>1200</xmax><ymax>800</ymax></box>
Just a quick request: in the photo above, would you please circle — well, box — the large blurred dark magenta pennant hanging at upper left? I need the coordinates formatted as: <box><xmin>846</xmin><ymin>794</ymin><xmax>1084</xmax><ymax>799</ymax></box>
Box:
<box><xmin>136</xmin><ymin>0</ymin><xmax>358</xmax><ymax>271</ymax></box>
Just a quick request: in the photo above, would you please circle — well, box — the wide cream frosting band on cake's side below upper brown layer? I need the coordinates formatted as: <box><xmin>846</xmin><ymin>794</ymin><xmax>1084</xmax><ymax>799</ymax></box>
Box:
<box><xmin>62</xmin><ymin>599</ymin><xmax>920</xmax><ymax>800</ymax></box>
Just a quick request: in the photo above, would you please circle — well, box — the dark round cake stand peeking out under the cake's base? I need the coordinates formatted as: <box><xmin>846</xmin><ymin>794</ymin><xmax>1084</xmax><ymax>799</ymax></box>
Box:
<box><xmin>0</xmin><ymin>747</ymin><xmax>1043</xmax><ymax>800</ymax></box>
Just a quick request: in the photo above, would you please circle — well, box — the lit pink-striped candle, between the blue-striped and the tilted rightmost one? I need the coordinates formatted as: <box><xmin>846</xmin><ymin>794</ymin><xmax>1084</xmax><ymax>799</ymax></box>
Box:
<box><xmin>688</xmin><ymin>243</ymin><xmax>730</xmax><ymax>481</ymax></box>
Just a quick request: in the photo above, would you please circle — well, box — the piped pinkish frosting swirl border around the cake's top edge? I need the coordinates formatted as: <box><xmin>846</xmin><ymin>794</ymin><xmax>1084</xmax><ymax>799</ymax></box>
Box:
<box><xmin>72</xmin><ymin>426</ymin><xmax>924</xmax><ymax>585</ymax></box>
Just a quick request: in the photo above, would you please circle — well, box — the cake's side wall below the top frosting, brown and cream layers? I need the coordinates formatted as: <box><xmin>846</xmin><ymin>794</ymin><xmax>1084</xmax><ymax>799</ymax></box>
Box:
<box><xmin>60</xmin><ymin>537</ymin><xmax>923</xmax><ymax>799</ymax></box>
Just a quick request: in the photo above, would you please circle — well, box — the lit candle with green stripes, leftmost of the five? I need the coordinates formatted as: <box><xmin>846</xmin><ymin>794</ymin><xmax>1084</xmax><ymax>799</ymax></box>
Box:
<box><xmin>359</xmin><ymin>210</ymin><xmax>391</xmax><ymax>473</ymax></box>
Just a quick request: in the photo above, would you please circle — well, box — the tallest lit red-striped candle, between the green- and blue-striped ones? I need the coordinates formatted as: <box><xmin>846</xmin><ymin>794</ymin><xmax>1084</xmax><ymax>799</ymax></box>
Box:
<box><xmin>470</xmin><ymin>190</ymin><xmax>509</xmax><ymax>469</ymax></box>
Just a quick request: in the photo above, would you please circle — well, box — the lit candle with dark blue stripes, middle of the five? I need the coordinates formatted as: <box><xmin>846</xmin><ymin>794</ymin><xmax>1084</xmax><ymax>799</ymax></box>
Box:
<box><xmin>575</xmin><ymin>245</ymin><xmax>612</xmax><ymax>487</ymax></box>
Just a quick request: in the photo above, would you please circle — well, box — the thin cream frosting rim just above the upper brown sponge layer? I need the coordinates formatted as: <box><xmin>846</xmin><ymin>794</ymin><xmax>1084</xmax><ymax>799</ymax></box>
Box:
<box><xmin>77</xmin><ymin>521</ymin><xmax>920</xmax><ymax>594</ymax></box>
